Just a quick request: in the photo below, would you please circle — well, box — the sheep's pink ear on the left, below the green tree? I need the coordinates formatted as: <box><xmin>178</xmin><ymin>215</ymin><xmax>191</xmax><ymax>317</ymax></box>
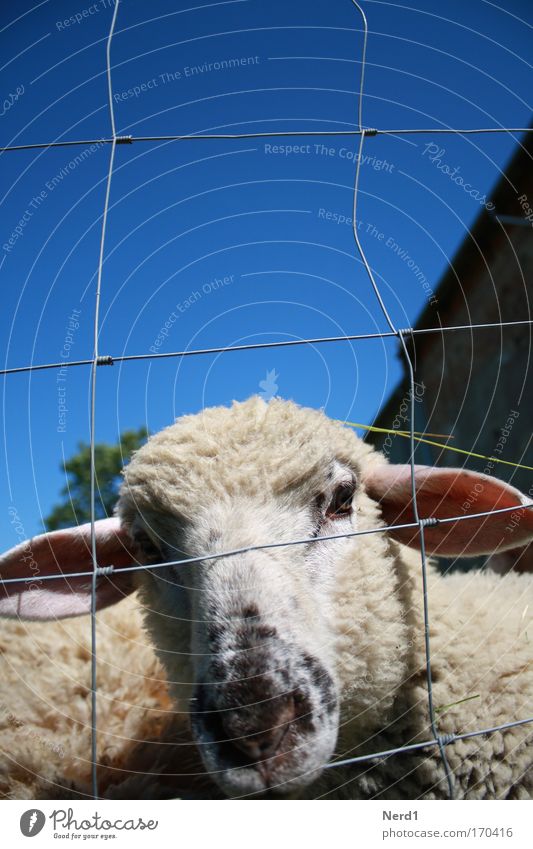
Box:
<box><xmin>0</xmin><ymin>518</ymin><xmax>134</xmax><ymax>619</ymax></box>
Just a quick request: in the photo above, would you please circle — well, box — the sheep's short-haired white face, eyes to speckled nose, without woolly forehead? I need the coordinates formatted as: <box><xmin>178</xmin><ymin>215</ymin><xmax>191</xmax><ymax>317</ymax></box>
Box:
<box><xmin>123</xmin><ymin>484</ymin><xmax>362</xmax><ymax>796</ymax></box>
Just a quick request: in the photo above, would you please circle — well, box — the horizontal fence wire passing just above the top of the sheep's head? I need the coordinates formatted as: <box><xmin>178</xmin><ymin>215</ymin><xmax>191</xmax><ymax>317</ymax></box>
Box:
<box><xmin>0</xmin><ymin>319</ymin><xmax>533</xmax><ymax>376</ymax></box>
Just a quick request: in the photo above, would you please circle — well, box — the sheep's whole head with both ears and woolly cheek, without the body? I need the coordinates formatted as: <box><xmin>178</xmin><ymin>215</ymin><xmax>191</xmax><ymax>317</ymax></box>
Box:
<box><xmin>0</xmin><ymin>398</ymin><xmax>533</xmax><ymax>797</ymax></box>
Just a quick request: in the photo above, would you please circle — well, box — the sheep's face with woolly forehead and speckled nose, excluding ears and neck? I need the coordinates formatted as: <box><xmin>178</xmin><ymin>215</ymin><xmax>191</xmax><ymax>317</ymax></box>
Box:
<box><xmin>120</xmin><ymin>401</ymin><xmax>386</xmax><ymax>796</ymax></box>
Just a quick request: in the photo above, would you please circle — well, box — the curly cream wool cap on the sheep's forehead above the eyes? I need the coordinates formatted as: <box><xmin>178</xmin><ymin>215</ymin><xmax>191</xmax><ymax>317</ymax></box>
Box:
<box><xmin>120</xmin><ymin>396</ymin><xmax>383</xmax><ymax>522</ymax></box>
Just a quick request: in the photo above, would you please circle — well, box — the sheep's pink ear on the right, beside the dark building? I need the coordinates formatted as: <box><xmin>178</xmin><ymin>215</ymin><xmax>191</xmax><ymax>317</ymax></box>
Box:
<box><xmin>366</xmin><ymin>465</ymin><xmax>533</xmax><ymax>557</ymax></box>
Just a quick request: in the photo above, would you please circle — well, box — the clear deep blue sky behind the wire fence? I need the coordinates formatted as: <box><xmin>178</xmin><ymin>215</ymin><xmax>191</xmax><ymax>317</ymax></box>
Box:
<box><xmin>0</xmin><ymin>0</ymin><xmax>533</xmax><ymax>547</ymax></box>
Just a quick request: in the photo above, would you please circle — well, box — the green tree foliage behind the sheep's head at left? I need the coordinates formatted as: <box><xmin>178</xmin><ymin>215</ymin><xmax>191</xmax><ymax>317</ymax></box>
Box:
<box><xmin>43</xmin><ymin>427</ymin><xmax>148</xmax><ymax>531</ymax></box>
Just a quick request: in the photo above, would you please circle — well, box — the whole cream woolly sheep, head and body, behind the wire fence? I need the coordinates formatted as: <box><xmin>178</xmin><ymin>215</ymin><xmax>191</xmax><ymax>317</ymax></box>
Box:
<box><xmin>0</xmin><ymin>397</ymin><xmax>533</xmax><ymax>799</ymax></box>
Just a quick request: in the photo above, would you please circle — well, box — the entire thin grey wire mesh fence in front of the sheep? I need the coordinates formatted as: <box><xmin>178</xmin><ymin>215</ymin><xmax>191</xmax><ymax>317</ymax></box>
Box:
<box><xmin>0</xmin><ymin>0</ymin><xmax>533</xmax><ymax>799</ymax></box>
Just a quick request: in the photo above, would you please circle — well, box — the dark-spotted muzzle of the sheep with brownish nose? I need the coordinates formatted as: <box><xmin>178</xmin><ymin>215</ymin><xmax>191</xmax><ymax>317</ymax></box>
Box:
<box><xmin>191</xmin><ymin>608</ymin><xmax>338</xmax><ymax>797</ymax></box>
